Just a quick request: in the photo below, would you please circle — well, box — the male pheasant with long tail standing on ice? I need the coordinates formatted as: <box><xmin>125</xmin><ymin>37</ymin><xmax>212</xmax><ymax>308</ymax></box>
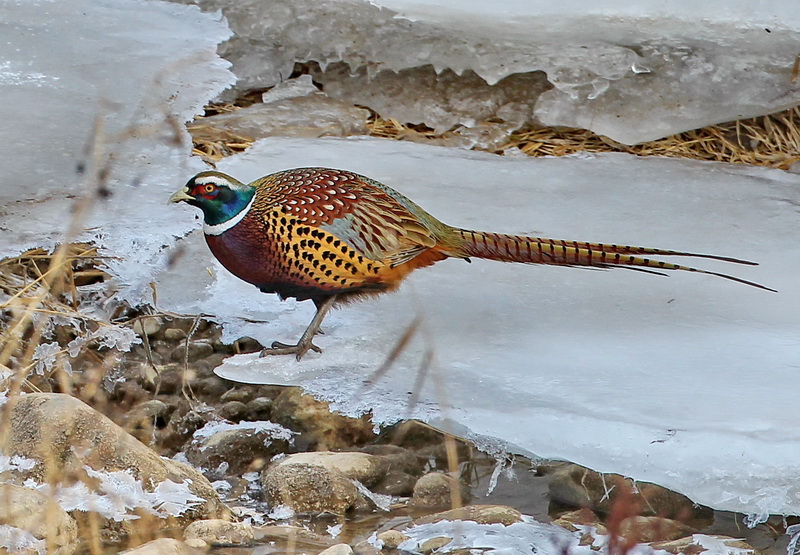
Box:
<box><xmin>169</xmin><ymin>168</ymin><xmax>772</xmax><ymax>360</ymax></box>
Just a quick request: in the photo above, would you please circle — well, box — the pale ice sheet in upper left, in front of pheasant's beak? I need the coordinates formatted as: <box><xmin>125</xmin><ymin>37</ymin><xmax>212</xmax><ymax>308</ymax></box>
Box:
<box><xmin>0</xmin><ymin>0</ymin><xmax>232</xmax><ymax>300</ymax></box>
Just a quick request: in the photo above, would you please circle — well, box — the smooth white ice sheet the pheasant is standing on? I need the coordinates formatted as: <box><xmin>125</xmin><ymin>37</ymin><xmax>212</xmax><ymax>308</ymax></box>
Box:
<box><xmin>158</xmin><ymin>139</ymin><xmax>800</xmax><ymax>514</ymax></box>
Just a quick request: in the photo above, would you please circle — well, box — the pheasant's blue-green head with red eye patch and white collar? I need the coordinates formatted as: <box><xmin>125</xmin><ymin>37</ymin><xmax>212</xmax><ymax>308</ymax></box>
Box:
<box><xmin>169</xmin><ymin>171</ymin><xmax>256</xmax><ymax>230</ymax></box>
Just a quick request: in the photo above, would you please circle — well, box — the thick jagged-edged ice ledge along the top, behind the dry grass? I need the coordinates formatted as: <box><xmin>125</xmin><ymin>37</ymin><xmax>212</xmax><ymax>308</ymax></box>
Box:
<box><xmin>184</xmin><ymin>0</ymin><xmax>800</xmax><ymax>144</ymax></box>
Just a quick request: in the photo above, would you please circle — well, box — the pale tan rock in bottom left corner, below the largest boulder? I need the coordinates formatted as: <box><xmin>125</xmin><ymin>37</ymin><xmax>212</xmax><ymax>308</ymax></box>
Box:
<box><xmin>0</xmin><ymin>484</ymin><xmax>78</xmax><ymax>553</ymax></box>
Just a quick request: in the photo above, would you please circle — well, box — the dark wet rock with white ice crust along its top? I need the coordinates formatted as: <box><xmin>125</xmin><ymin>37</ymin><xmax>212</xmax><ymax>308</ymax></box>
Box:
<box><xmin>186</xmin><ymin>423</ymin><xmax>289</xmax><ymax>476</ymax></box>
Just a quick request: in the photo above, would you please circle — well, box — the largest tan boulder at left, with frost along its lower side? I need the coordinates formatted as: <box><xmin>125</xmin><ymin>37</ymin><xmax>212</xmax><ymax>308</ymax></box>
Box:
<box><xmin>0</xmin><ymin>393</ymin><xmax>229</xmax><ymax>526</ymax></box>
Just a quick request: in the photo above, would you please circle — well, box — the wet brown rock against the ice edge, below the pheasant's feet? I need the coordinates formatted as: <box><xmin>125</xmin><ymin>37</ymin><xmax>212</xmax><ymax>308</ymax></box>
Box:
<box><xmin>272</xmin><ymin>387</ymin><xmax>375</xmax><ymax>451</ymax></box>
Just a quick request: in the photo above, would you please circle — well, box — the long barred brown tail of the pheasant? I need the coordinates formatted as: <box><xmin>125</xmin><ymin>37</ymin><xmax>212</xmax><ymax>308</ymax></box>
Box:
<box><xmin>455</xmin><ymin>229</ymin><xmax>775</xmax><ymax>291</ymax></box>
